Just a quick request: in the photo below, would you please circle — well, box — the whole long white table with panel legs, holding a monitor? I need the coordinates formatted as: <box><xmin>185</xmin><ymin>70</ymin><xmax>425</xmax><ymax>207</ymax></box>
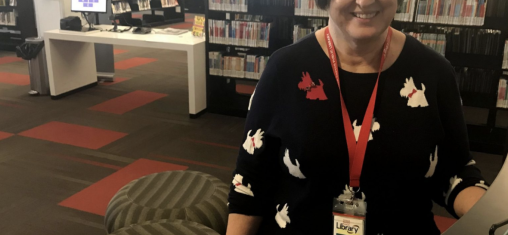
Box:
<box><xmin>44</xmin><ymin>25</ymin><xmax>206</xmax><ymax>117</ymax></box>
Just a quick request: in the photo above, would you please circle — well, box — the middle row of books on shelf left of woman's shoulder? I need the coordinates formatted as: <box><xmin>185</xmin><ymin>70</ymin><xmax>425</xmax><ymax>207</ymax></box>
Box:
<box><xmin>208</xmin><ymin>19</ymin><xmax>271</xmax><ymax>48</ymax></box>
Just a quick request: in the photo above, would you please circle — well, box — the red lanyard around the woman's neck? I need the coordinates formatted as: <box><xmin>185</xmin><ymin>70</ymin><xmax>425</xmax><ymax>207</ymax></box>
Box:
<box><xmin>325</xmin><ymin>27</ymin><xmax>392</xmax><ymax>187</ymax></box>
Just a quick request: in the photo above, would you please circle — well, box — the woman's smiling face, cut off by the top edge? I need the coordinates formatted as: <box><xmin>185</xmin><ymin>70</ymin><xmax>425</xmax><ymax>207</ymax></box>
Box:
<box><xmin>329</xmin><ymin>0</ymin><xmax>397</xmax><ymax>40</ymax></box>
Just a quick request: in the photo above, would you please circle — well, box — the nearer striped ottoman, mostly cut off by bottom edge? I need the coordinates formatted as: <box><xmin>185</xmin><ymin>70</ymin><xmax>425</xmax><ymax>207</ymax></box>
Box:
<box><xmin>112</xmin><ymin>220</ymin><xmax>219</xmax><ymax>235</ymax></box>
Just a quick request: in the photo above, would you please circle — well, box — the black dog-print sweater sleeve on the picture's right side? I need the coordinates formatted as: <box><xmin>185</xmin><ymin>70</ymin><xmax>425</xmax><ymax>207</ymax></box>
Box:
<box><xmin>432</xmin><ymin>66</ymin><xmax>488</xmax><ymax>218</ymax></box>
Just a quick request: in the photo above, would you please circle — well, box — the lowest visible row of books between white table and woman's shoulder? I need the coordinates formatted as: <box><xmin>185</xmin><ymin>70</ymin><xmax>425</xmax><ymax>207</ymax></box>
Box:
<box><xmin>208</xmin><ymin>51</ymin><xmax>270</xmax><ymax>80</ymax></box>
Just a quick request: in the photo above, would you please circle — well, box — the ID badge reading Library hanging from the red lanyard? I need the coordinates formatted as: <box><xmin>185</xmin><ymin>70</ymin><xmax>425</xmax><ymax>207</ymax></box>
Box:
<box><xmin>333</xmin><ymin>186</ymin><xmax>367</xmax><ymax>235</ymax></box>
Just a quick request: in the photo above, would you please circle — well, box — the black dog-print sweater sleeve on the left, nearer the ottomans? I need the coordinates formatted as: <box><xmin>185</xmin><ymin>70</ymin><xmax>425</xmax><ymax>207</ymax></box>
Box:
<box><xmin>228</xmin><ymin>54</ymin><xmax>281</xmax><ymax>216</ymax></box>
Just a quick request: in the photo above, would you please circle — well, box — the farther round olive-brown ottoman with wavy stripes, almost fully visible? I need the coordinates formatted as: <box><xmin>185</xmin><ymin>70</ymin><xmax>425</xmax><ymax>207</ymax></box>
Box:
<box><xmin>105</xmin><ymin>171</ymin><xmax>229</xmax><ymax>234</ymax></box>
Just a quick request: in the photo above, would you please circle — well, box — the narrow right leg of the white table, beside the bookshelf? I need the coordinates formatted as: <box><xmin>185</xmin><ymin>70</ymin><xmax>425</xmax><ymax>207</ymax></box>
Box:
<box><xmin>187</xmin><ymin>43</ymin><xmax>206</xmax><ymax>118</ymax></box>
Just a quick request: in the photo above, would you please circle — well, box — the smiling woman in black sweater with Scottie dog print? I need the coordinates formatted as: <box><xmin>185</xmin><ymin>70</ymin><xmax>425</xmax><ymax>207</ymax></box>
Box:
<box><xmin>227</xmin><ymin>0</ymin><xmax>487</xmax><ymax>235</ymax></box>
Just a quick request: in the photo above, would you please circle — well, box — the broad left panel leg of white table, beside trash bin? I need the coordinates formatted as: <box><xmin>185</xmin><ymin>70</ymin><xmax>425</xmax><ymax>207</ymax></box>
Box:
<box><xmin>44</xmin><ymin>38</ymin><xmax>97</xmax><ymax>99</ymax></box>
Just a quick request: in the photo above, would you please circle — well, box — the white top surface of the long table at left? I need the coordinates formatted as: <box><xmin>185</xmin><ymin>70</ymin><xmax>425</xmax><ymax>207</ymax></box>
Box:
<box><xmin>44</xmin><ymin>25</ymin><xmax>205</xmax><ymax>50</ymax></box>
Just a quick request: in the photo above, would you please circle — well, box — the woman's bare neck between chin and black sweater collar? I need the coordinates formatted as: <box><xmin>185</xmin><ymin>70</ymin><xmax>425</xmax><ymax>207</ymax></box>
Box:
<box><xmin>329</xmin><ymin>20</ymin><xmax>388</xmax><ymax>73</ymax></box>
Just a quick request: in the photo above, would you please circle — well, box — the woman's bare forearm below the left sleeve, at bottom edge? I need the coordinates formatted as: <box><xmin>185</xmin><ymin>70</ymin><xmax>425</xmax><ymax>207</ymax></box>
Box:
<box><xmin>226</xmin><ymin>214</ymin><xmax>263</xmax><ymax>235</ymax></box>
